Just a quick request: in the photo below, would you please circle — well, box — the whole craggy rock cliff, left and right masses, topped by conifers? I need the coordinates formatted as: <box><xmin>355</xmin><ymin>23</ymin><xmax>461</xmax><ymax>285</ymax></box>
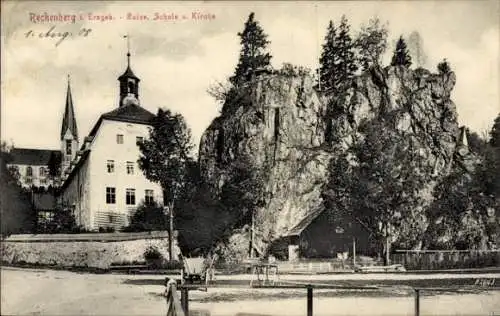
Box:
<box><xmin>199</xmin><ymin>67</ymin><xmax>472</xmax><ymax>256</ymax></box>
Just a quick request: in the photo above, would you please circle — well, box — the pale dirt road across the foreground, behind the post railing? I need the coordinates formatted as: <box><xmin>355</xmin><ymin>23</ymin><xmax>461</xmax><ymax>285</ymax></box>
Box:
<box><xmin>1</xmin><ymin>268</ymin><xmax>500</xmax><ymax>316</ymax></box>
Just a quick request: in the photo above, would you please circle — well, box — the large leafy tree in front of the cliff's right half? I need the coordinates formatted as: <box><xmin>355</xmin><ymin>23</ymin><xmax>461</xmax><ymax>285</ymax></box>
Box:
<box><xmin>325</xmin><ymin>115</ymin><xmax>430</xmax><ymax>264</ymax></box>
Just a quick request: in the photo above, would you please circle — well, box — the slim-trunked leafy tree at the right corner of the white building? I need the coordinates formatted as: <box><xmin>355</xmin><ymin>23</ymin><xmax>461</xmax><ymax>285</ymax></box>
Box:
<box><xmin>137</xmin><ymin>109</ymin><xmax>194</xmax><ymax>258</ymax></box>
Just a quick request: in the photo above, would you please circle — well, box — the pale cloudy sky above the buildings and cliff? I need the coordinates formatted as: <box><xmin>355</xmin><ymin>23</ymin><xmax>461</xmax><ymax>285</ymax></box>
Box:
<box><xmin>0</xmin><ymin>0</ymin><xmax>500</xmax><ymax>153</ymax></box>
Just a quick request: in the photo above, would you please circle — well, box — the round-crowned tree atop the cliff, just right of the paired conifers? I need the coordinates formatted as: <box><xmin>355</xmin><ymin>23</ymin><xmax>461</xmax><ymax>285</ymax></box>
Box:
<box><xmin>355</xmin><ymin>17</ymin><xmax>388</xmax><ymax>69</ymax></box>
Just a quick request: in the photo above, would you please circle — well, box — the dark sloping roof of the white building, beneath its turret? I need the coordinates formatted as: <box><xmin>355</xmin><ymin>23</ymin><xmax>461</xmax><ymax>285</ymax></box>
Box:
<box><xmin>89</xmin><ymin>104</ymin><xmax>155</xmax><ymax>136</ymax></box>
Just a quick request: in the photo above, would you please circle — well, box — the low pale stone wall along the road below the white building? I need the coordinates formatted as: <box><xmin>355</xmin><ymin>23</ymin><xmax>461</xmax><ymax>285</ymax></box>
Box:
<box><xmin>2</xmin><ymin>232</ymin><xmax>180</xmax><ymax>269</ymax></box>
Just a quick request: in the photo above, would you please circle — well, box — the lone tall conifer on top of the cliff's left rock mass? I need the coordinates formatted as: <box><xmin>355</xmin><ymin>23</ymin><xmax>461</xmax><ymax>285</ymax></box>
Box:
<box><xmin>229</xmin><ymin>12</ymin><xmax>272</xmax><ymax>86</ymax></box>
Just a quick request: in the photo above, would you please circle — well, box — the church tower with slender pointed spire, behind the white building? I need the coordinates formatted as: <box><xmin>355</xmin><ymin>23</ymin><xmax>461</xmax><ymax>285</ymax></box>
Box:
<box><xmin>61</xmin><ymin>75</ymin><xmax>79</xmax><ymax>176</ymax></box>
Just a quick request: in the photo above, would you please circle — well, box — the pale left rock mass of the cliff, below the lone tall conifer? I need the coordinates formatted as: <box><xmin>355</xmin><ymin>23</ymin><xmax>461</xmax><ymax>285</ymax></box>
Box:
<box><xmin>199</xmin><ymin>75</ymin><xmax>330</xmax><ymax>247</ymax></box>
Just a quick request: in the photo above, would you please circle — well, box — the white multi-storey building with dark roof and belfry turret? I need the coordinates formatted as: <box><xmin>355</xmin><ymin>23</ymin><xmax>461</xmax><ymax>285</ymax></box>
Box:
<box><xmin>58</xmin><ymin>54</ymin><xmax>163</xmax><ymax>230</ymax></box>
